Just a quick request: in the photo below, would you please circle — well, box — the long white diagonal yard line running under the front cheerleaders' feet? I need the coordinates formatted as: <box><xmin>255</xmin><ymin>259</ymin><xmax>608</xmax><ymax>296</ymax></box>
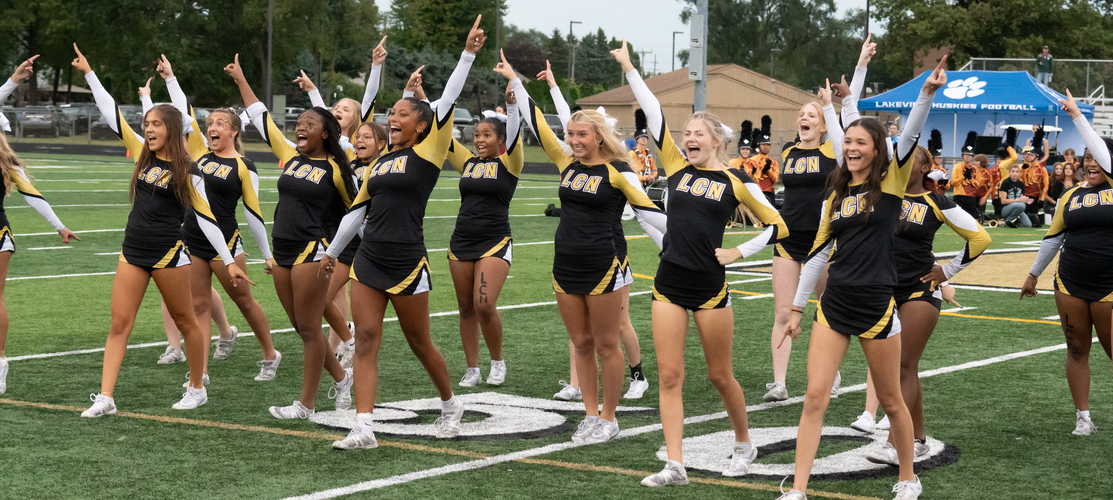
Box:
<box><xmin>278</xmin><ymin>339</ymin><xmax>1097</xmax><ymax>500</ymax></box>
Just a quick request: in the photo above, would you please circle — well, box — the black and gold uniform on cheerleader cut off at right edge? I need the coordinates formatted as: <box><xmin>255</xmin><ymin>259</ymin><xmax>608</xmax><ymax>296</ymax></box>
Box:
<box><xmin>1030</xmin><ymin>182</ymin><xmax>1113</xmax><ymax>302</ymax></box>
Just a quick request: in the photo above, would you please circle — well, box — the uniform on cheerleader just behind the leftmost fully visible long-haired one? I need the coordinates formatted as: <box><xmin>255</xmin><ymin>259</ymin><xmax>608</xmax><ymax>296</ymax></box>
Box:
<box><xmin>183</xmin><ymin>113</ymin><xmax>273</xmax><ymax>261</ymax></box>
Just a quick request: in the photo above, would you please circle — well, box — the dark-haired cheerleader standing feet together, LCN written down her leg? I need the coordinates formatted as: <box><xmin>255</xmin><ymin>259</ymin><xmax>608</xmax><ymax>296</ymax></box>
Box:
<box><xmin>440</xmin><ymin>80</ymin><xmax>524</xmax><ymax>388</ymax></box>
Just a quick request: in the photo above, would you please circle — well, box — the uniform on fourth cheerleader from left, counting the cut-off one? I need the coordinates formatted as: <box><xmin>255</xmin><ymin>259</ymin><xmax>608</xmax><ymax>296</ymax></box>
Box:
<box><xmin>247</xmin><ymin>102</ymin><xmax>354</xmax><ymax>267</ymax></box>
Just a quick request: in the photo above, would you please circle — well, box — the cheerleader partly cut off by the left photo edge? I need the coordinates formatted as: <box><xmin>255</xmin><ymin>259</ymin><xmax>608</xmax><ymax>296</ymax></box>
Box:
<box><xmin>0</xmin><ymin>56</ymin><xmax>81</xmax><ymax>394</ymax></box>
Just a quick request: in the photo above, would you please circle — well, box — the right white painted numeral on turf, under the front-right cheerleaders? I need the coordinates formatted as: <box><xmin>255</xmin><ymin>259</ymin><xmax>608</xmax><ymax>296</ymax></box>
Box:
<box><xmin>657</xmin><ymin>427</ymin><xmax>959</xmax><ymax>481</ymax></box>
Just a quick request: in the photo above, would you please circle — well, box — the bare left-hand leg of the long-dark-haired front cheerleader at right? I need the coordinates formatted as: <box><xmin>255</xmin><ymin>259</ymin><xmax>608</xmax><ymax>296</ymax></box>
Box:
<box><xmin>792</xmin><ymin>320</ymin><xmax>850</xmax><ymax>491</ymax></box>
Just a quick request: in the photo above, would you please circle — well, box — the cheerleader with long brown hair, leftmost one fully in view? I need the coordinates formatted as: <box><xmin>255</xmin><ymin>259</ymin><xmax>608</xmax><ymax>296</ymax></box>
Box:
<box><xmin>72</xmin><ymin>43</ymin><xmax>252</xmax><ymax>416</ymax></box>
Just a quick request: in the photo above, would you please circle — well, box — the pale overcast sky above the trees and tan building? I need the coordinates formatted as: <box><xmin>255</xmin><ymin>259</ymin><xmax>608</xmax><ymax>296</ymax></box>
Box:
<box><xmin>375</xmin><ymin>0</ymin><xmax>876</xmax><ymax>72</ymax></box>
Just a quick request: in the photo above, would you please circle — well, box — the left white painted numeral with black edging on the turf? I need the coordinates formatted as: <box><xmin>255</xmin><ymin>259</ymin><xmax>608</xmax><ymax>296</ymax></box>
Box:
<box><xmin>309</xmin><ymin>392</ymin><xmax>657</xmax><ymax>440</ymax></box>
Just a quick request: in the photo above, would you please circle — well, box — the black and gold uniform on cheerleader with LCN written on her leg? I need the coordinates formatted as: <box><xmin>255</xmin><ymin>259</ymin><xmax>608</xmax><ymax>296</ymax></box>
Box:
<box><xmin>449</xmin><ymin>105</ymin><xmax>525</xmax><ymax>264</ymax></box>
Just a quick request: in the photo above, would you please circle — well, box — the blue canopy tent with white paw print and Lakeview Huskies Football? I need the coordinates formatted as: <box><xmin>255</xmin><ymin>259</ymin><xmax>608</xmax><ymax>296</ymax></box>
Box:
<box><xmin>858</xmin><ymin>71</ymin><xmax>1094</xmax><ymax>157</ymax></box>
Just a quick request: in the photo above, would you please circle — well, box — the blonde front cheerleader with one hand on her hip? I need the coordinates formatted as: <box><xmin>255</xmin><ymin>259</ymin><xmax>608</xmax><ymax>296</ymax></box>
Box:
<box><xmin>611</xmin><ymin>40</ymin><xmax>788</xmax><ymax>487</ymax></box>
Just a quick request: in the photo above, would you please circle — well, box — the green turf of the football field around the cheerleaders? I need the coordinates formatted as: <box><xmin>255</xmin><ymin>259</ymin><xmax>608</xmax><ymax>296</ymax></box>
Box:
<box><xmin>0</xmin><ymin>155</ymin><xmax>1113</xmax><ymax>499</ymax></box>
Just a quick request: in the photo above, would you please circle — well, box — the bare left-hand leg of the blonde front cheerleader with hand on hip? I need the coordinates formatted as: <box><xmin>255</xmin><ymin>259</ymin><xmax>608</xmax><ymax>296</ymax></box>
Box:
<box><xmin>652</xmin><ymin>301</ymin><xmax>688</xmax><ymax>462</ymax></box>
